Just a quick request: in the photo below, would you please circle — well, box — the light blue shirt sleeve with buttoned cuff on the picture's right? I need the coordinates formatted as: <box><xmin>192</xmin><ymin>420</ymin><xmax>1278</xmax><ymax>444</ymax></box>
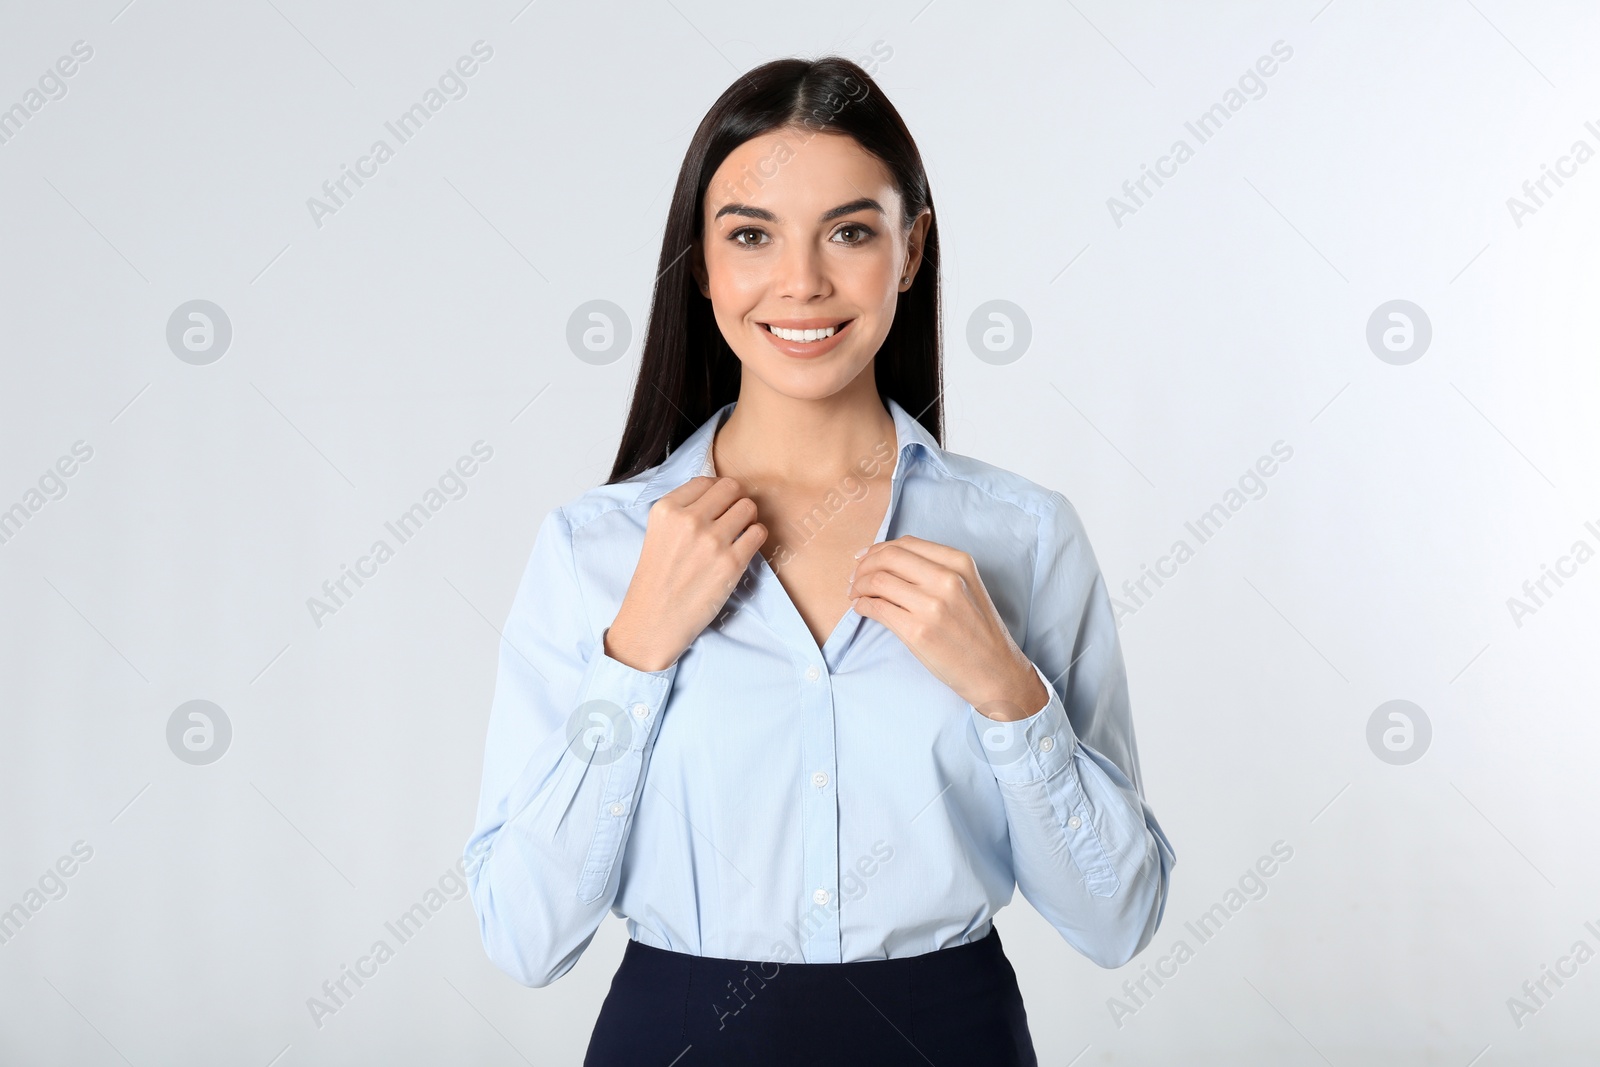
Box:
<box><xmin>971</xmin><ymin>493</ymin><xmax>1176</xmax><ymax>968</ymax></box>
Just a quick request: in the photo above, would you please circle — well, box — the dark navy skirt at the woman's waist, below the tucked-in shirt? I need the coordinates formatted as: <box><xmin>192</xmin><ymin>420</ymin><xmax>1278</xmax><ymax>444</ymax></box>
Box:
<box><xmin>584</xmin><ymin>928</ymin><xmax>1038</xmax><ymax>1067</ymax></box>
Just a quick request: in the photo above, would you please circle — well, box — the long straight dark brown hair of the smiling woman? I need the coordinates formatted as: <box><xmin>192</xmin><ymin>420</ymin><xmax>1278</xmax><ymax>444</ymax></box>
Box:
<box><xmin>606</xmin><ymin>56</ymin><xmax>944</xmax><ymax>485</ymax></box>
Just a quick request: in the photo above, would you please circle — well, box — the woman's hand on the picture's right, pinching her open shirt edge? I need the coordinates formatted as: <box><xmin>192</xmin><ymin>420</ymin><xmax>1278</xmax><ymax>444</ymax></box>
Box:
<box><xmin>850</xmin><ymin>534</ymin><xmax>1050</xmax><ymax>721</ymax></box>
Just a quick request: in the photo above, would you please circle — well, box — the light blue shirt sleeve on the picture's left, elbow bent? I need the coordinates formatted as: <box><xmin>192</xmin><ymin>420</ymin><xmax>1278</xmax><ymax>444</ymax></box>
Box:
<box><xmin>466</xmin><ymin>507</ymin><xmax>677</xmax><ymax>985</ymax></box>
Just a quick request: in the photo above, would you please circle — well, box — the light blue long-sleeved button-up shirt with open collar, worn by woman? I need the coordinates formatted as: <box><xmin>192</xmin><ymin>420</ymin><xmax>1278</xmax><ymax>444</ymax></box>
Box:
<box><xmin>466</xmin><ymin>400</ymin><xmax>1176</xmax><ymax>985</ymax></box>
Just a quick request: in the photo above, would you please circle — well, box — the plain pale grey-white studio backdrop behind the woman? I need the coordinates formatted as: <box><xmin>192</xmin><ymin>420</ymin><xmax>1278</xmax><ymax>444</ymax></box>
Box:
<box><xmin>0</xmin><ymin>0</ymin><xmax>1600</xmax><ymax>1067</ymax></box>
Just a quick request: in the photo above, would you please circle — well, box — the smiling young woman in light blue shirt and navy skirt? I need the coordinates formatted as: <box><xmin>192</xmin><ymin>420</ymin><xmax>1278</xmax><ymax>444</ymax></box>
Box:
<box><xmin>467</xmin><ymin>58</ymin><xmax>1174</xmax><ymax>1067</ymax></box>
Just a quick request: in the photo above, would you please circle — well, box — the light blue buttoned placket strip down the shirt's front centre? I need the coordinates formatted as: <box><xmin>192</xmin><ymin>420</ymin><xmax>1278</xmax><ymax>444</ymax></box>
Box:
<box><xmin>798</xmin><ymin>659</ymin><xmax>843</xmax><ymax>963</ymax></box>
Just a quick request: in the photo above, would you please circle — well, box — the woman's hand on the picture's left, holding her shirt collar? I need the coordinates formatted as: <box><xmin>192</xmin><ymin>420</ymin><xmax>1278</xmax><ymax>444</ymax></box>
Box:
<box><xmin>603</xmin><ymin>475</ymin><xmax>766</xmax><ymax>670</ymax></box>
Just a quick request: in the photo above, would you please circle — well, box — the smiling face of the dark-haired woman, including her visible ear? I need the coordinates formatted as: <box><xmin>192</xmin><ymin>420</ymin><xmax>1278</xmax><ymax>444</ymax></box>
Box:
<box><xmin>693</xmin><ymin>128</ymin><xmax>933</xmax><ymax>400</ymax></box>
